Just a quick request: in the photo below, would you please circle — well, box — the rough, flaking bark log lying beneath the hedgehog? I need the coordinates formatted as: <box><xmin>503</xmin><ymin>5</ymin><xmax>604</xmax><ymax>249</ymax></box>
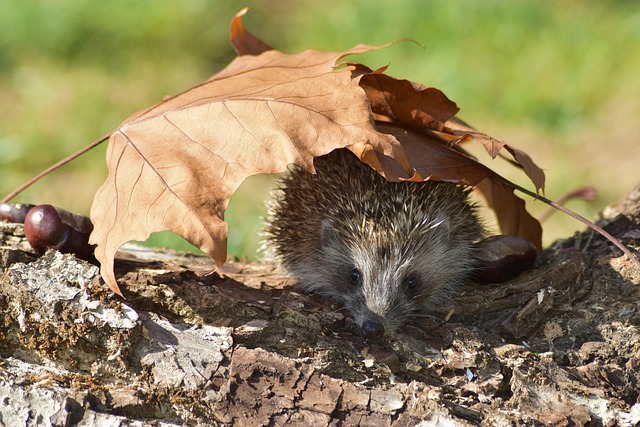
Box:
<box><xmin>0</xmin><ymin>188</ymin><xmax>640</xmax><ymax>426</ymax></box>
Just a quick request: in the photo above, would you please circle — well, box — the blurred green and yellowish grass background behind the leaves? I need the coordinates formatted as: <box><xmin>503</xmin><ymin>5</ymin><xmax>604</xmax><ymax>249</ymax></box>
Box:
<box><xmin>0</xmin><ymin>0</ymin><xmax>640</xmax><ymax>259</ymax></box>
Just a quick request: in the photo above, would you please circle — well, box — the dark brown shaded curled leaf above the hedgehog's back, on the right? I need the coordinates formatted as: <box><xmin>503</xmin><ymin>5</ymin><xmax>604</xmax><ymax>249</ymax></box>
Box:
<box><xmin>351</xmin><ymin>64</ymin><xmax>544</xmax><ymax>248</ymax></box>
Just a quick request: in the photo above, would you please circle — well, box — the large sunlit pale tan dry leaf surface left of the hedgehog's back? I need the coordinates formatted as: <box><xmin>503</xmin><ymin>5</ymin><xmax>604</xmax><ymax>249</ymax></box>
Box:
<box><xmin>91</xmin><ymin>32</ymin><xmax>396</xmax><ymax>293</ymax></box>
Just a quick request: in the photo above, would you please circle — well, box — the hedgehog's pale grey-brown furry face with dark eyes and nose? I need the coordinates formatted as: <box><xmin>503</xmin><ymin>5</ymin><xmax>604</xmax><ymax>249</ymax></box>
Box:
<box><xmin>322</xmin><ymin>225</ymin><xmax>462</xmax><ymax>338</ymax></box>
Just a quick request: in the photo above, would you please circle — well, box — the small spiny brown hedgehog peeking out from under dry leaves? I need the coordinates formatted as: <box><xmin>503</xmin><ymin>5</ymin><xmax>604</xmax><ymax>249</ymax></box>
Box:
<box><xmin>265</xmin><ymin>149</ymin><xmax>484</xmax><ymax>339</ymax></box>
